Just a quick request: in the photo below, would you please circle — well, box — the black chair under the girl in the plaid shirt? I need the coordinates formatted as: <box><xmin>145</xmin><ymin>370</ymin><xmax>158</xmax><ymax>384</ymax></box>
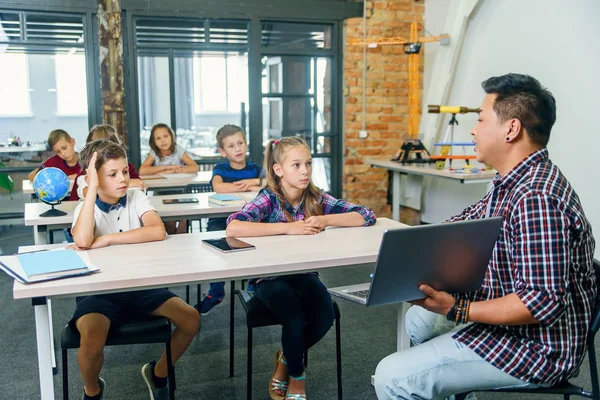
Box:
<box><xmin>229</xmin><ymin>290</ymin><xmax>342</xmax><ymax>400</ymax></box>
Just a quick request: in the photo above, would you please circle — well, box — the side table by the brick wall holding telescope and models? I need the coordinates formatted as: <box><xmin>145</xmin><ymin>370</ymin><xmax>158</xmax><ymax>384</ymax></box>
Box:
<box><xmin>364</xmin><ymin>158</ymin><xmax>496</xmax><ymax>221</ymax></box>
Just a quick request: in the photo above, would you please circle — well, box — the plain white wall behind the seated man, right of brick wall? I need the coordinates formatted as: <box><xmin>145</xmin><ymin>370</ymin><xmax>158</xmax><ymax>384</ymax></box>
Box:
<box><xmin>421</xmin><ymin>0</ymin><xmax>600</xmax><ymax>257</ymax></box>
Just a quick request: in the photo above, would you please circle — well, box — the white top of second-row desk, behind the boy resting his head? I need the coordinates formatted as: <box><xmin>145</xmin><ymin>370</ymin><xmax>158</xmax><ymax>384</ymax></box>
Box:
<box><xmin>25</xmin><ymin>192</ymin><xmax>257</xmax><ymax>226</ymax></box>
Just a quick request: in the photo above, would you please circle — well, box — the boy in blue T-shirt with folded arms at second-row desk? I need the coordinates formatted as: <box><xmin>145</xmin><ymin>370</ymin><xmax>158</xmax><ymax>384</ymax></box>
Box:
<box><xmin>195</xmin><ymin>125</ymin><xmax>264</xmax><ymax>315</ymax></box>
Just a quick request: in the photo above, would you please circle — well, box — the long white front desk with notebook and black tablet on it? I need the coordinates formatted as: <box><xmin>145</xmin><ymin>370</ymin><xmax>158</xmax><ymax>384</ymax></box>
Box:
<box><xmin>13</xmin><ymin>218</ymin><xmax>407</xmax><ymax>400</ymax></box>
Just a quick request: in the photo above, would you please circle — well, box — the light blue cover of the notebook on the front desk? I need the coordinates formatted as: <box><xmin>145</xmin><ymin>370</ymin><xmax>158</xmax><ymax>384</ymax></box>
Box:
<box><xmin>17</xmin><ymin>249</ymin><xmax>87</xmax><ymax>279</ymax></box>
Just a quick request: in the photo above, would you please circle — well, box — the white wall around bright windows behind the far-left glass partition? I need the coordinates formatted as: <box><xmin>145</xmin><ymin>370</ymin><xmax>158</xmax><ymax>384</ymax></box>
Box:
<box><xmin>0</xmin><ymin>54</ymin><xmax>89</xmax><ymax>148</ymax></box>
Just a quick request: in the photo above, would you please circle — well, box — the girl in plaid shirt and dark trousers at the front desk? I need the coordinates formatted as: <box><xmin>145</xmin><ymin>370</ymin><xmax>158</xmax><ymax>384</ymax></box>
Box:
<box><xmin>227</xmin><ymin>137</ymin><xmax>376</xmax><ymax>400</ymax></box>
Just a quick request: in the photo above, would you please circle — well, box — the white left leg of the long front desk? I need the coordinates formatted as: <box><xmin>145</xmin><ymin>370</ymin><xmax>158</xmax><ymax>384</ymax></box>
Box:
<box><xmin>32</xmin><ymin>298</ymin><xmax>54</xmax><ymax>400</ymax></box>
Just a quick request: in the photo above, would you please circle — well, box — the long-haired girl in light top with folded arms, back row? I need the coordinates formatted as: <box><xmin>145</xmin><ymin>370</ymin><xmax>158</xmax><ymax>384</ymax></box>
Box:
<box><xmin>140</xmin><ymin>124</ymin><xmax>200</xmax><ymax>234</ymax></box>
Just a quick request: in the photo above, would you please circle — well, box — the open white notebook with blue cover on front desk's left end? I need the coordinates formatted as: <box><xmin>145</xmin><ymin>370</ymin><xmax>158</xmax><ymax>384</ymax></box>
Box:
<box><xmin>0</xmin><ymin>249</ymin><xmax>99</xmax><ymax>283</ymax></box>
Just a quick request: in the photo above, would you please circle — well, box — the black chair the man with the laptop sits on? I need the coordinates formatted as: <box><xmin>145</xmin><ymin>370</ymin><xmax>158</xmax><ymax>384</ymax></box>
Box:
<box><xmin>478</xmin><ymin>260</ymin><xmax>600</xmax><ymax>400</ymax></box>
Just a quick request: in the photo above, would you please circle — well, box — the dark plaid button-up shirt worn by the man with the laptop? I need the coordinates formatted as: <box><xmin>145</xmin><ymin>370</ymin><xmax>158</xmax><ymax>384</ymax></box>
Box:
<box><xmin>449</xmin><ymin>148</ymin><xmax>597</xmax><ymax>385</ymax></box>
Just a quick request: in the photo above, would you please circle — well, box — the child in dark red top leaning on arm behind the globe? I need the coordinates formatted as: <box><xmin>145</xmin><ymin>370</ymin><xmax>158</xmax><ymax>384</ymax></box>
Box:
<box><xmin>27</xmin><ymin>129</ymin><xmax>81</xmax><ymax>182</ymax></box>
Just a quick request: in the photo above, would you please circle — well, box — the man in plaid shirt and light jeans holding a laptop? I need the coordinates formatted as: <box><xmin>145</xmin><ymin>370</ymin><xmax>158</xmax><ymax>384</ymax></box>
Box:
<box><xmin>375</xmin><ymin>74</ymin><xmax>597</xmax><ymax>399</ymax></box>
